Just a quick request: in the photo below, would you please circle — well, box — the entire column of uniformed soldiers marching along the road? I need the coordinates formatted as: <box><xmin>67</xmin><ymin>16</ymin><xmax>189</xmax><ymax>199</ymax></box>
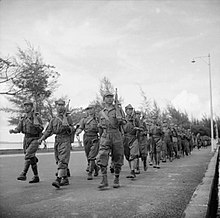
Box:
<box><xmin>9</xmin><ymin>92</ymin><xmax>193</xmax><ymax>189</ymax></box>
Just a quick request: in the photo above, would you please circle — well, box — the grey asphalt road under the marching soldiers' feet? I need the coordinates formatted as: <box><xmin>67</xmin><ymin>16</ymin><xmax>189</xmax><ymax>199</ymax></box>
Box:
<box><xmin>0</xmin><ymin>148</ymin><xmax>212</xmax><ymax>218</ymax></box>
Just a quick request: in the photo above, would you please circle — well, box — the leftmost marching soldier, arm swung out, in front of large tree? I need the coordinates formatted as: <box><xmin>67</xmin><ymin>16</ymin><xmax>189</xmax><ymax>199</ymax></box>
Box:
<box><xmin>9</xmin><ymin>101</ymin><xmax>43</xmax><ymax>183</ymax></box>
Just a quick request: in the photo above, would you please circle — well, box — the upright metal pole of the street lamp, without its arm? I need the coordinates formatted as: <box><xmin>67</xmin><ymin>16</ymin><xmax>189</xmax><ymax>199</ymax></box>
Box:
<box><xmin>208</xmin><ymin>54</ymin><xmax>214</xmax><ymax>152</ymax></box>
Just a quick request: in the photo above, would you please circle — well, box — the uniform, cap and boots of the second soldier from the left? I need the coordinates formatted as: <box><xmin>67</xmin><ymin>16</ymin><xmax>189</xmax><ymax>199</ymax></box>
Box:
<box><xmin>40</xmin><ymin>100</ymin><xmax>75</xmax><ymax>188</ymax></box>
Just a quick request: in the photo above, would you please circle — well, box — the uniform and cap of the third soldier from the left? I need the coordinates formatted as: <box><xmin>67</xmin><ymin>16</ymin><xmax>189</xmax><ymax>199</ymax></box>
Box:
<box><xmin>76</xmin><ymin>105</ymin><xmax>99</xmax><ymax>180</ymax></box>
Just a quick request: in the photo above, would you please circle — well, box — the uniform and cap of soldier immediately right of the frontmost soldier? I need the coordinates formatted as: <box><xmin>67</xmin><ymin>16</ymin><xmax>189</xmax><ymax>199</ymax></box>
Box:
<box><xmin>123</xmin><ymin>104</ymin><xmax>139</xmax><ymax>178</ymax></box>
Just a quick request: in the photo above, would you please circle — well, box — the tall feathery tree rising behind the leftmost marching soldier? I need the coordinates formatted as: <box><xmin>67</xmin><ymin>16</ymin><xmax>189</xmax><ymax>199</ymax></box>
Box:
<box><xmin>1</xmin><ymin>44</ymin><xmax>59</xmax><ymax>125</ymax></box>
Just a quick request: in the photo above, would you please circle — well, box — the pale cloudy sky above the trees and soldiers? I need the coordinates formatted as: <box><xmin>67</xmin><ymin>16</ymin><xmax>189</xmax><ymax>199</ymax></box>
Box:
<box><xmin>0</xmin><ymin>0</ymin><xmax>220</xmax><ymax>141</ymax></box>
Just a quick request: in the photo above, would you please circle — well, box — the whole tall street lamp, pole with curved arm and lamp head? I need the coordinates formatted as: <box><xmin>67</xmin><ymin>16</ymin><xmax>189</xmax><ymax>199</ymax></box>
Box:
<box><xmin>192</xmin><ymin>54</ymin><xmax>214</xmax><ymax>152</ymax></box>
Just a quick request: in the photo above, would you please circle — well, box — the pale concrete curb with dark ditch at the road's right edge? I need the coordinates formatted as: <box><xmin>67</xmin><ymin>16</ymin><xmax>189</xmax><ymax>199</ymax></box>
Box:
<box><xmin>181</xmin><ymin>148</ymin><xmax>219</xmax><ymax>218</ymax></box>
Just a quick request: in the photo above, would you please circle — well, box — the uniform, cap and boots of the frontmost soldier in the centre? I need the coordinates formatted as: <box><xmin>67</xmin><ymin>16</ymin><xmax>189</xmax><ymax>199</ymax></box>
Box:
<box><xmin>97</xmin><ymin>92</ymin><xmax>124</xmax><ymax>188</ymax></box>
